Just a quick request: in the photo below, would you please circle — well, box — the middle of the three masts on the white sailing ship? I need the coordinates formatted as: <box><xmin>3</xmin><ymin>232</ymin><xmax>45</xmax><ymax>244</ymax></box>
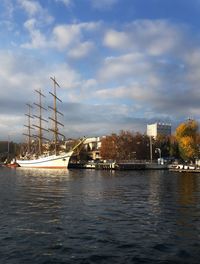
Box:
<box><xmin>33</xmin><ymin>89</ymin><xmax>48</xmax><ymax>155</ymax></box>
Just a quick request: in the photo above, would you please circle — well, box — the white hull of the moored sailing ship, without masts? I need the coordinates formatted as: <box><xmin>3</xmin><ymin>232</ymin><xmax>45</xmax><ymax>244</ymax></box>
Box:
<box><xmin>16</xmin><ymin>151</ymin><xmax>73</xmax><ymax>168</ymax></box>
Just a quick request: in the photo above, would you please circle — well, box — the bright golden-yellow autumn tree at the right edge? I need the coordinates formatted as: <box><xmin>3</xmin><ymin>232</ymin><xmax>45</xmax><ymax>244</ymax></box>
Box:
<box><xmin>176</xmin><ymin>119</ymin><xmax>199</xmax><ymax>160</ymax></box>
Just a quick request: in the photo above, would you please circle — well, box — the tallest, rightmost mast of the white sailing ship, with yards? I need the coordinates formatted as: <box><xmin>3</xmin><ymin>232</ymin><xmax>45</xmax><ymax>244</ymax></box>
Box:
<box><xmin>49</xmin><ymin>77</ymin><xmax>64</xmax><ymax>155</ymax></box>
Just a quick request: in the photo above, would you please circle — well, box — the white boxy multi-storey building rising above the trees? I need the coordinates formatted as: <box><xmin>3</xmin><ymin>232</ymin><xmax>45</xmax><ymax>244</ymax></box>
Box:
<box><xmin>147</xmin><ymin>123</ymin><xmax>171</xmax><ymax>138</ymax></box>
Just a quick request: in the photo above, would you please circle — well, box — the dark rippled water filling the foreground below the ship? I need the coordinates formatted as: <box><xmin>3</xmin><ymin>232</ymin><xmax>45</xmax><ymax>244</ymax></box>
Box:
<box><xmin>0</xmin><ymin>168</ymin><xmax>200</xmax><ymax>264</ymax></box>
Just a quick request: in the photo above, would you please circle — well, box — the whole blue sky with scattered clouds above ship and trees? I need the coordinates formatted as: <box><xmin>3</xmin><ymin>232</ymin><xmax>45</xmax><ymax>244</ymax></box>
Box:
<box><xmin>0</xmin><ymin>0</ymin><xmax>200</xmax><ymax>141</ymax></box>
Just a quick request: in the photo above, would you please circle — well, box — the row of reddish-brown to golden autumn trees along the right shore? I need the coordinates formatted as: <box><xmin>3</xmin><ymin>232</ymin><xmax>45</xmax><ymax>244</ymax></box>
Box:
<box><xmin>100</xmin><ymin>119</ymin><xmax>200</xmax><ymax>161</ymax></box>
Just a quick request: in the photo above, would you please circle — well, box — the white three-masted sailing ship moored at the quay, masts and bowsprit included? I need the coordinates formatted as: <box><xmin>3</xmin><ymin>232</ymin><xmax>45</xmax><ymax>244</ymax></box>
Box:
<box><xmin>16</xmin><ymin>77</ymin><xmax>85</xmax><ymax>168</ymax></box>
